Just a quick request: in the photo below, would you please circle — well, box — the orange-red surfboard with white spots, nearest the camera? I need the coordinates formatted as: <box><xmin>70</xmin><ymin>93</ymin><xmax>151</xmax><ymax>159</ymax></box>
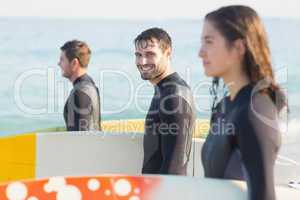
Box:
<box><xmin>0</xmin><ymin>175</ymin><xmax>300</xmax><ymax>200</ymax></box>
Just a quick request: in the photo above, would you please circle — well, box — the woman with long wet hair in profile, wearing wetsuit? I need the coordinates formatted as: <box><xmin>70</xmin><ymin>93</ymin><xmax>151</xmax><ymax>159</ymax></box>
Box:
<box><xmin>199</xmin><ymin>6</ymin><xmax>286</xmax><ymax>200</ymax></box>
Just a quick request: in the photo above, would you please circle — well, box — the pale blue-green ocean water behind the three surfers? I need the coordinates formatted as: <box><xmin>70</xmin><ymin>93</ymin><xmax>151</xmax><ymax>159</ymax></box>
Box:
<box><xmin>0</xmin><ymin>17</ymin><xmax>300</xmax><ymax>135</ymax></box>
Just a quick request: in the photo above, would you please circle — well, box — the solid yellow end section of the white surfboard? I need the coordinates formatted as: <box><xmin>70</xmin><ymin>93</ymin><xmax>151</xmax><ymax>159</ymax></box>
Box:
<box><xmin>0</xmin><ymin>133</ymin><xmax>36</xmax><ymax>182</ymax></box>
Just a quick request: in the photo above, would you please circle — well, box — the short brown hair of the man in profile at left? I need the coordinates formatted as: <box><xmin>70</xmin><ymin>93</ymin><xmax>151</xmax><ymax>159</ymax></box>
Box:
<box><xmin>60</xmin><ymin>40</ymin><xmax>91</xmax><ymax>68</ymax></box>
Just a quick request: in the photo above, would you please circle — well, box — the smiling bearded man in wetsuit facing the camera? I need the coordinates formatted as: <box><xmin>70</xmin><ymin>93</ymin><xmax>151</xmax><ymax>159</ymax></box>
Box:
<box><xmin>134</xmin><ymin>28</ymin><xmax>196</xmax><ymax>175</ymax></box>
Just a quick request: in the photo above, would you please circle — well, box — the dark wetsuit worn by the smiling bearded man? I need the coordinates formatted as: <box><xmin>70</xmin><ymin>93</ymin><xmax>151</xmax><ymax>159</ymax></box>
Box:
<box><xmin>142</xmin><ymin>73</ymin><xmax>195</xmax><ymax>175</ymax></box>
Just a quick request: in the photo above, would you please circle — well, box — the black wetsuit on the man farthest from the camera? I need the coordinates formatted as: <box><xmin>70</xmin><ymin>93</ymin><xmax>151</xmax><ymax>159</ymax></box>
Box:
<box><xmin>64</xmin><ymin>74</ymin><xmax>101</xmax><ymax>131</ymax></box>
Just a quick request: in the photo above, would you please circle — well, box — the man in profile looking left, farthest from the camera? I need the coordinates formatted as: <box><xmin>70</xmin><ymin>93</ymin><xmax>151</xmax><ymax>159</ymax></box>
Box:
<box><xmin>58</xmin><ymin>40</ymin><xmax>101</xmax><ymax>131</ymax></box>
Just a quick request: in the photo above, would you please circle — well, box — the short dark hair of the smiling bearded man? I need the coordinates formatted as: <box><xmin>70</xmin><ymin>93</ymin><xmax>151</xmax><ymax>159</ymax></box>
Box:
<box><xmin>134</xmin><ymin>28</ymin><xmax>172</xmax><ymax>52</ymax></box>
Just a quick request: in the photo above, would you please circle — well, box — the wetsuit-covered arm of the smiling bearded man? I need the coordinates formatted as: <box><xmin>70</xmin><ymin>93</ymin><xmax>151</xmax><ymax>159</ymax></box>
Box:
<box><xmin>159</xmin><ymin>95</ymin><xmax>193</xmax><ymax>174</ymax></box>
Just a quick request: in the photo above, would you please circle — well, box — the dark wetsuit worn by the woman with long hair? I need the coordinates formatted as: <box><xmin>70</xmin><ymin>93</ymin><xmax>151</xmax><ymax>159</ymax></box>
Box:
<box><xmin>202</xmin><ymin>84</ymin><xmax>281</xmax><ymax>200</ymax></box>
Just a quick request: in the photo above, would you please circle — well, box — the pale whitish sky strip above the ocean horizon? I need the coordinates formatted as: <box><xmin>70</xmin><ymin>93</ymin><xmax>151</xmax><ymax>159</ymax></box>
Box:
<box><xmin>0</xmin><ymin>0</ymin><xmax>300</xmax><ymax>19</ymax></box>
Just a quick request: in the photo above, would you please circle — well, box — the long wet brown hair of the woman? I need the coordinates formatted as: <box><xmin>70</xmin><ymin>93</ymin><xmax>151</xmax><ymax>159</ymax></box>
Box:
<box><xmin>205</xmin><ymin>5</ymin><xmax>287</xmax><ymax>110</ymax></box>
